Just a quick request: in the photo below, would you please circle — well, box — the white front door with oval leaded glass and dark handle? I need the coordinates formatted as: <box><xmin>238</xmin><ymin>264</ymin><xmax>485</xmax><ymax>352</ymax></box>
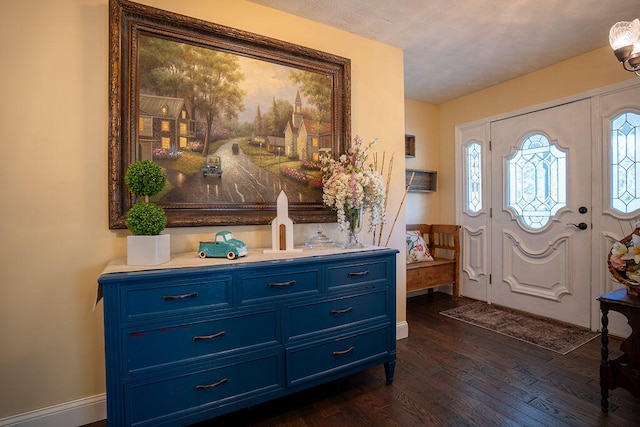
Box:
<box><xmin>488</xmin><ymin>99</ymin><xmax>592</xmax><ymax>327</ymax></box>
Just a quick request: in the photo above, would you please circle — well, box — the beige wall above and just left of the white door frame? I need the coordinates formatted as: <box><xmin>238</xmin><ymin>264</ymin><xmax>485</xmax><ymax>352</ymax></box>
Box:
<box><xmin>436</xmin><ymin>46</ymin><xmax>637</xmax><ymax>222</ymax></box>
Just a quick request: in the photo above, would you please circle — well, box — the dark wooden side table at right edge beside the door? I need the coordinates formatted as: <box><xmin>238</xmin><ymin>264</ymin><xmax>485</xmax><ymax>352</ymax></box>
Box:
<box><xmin>596</xmin><ymin>288</ymin><xmax>640</xmax><ymax>412</ymax></box>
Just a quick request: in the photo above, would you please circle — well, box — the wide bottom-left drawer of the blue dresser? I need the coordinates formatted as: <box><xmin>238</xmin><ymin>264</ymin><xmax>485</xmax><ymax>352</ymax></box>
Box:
<box><xmin>125</xmin><ymin>354</ymin><xmax>282</xmax><ymax>426</ymax></box>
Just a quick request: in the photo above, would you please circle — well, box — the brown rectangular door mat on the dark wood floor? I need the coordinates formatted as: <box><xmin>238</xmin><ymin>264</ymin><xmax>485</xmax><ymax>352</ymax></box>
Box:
<box><xmin>440</xmin><ymin>301</ymin><xmax>600</xmax><ymax>354</ymax></box>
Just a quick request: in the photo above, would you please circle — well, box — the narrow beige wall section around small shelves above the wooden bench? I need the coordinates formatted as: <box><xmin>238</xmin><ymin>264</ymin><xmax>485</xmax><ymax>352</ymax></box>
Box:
<box><xmin>404</xmin><ymin>99</ymin><xmax>446</xmax><ymax>224</ymax></box>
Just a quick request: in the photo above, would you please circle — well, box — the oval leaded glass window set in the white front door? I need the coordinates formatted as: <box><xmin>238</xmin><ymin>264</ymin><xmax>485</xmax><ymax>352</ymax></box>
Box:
<box><xmin>507</xmin><ymin>133</ymin><xmax>567</xmax><ymax>229</ymax></box>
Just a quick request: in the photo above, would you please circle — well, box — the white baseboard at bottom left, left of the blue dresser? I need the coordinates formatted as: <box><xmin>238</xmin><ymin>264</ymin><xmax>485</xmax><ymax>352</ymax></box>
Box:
<box><xmin>0</xmin><ymin>393</ymin><xmax>107</xmax><ymax>427</ymax></box>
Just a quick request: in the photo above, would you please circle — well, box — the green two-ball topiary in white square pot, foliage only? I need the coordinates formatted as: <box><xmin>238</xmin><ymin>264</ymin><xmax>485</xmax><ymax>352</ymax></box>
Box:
<box><xmin>124</xmin><ymin>160</ymin><xmax>167</xmax><ymax>236</ymax></box>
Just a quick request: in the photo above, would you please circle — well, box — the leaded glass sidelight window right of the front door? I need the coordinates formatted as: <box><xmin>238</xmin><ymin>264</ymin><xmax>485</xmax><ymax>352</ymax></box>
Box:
<box><xmin>611</xmin><ymin>112</ymin><xmax>640</xmax><ymax>213</ymax></box>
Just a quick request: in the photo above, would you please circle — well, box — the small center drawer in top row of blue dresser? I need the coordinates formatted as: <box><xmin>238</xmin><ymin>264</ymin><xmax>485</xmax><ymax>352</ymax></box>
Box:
<box><xmin>238</xmin><ymin>268</ymin><xmax>320</xmax><ymax>303</ymax></box>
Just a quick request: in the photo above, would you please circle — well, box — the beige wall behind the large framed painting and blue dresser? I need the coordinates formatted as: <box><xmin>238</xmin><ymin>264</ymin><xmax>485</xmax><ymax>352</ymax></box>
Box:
<box><xmin>0</xmin><ymin>0</ymin><xmax>405</xmax><ymax>419</ymax></box>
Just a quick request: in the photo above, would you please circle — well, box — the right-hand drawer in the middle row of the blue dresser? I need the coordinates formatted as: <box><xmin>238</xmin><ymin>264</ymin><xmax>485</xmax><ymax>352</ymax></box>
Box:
<box><xmin>287</xmin><ymin>288</ymin><xmax>389</xmax><ymax>339</ymax></box>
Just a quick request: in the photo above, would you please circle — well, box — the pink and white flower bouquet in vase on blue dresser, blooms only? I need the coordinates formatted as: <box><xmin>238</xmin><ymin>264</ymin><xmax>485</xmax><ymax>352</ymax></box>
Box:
<box><xmin>320</xmin><ymin>136</ymin><xmax>386</xmax><ymax>239</ymax></box>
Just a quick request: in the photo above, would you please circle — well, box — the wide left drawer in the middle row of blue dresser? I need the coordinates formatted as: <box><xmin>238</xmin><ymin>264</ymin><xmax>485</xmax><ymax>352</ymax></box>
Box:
<box><xmin>124</xmin><ymin>310</ymin><xmax>280</xmax><ymax>373</ymax></box>
